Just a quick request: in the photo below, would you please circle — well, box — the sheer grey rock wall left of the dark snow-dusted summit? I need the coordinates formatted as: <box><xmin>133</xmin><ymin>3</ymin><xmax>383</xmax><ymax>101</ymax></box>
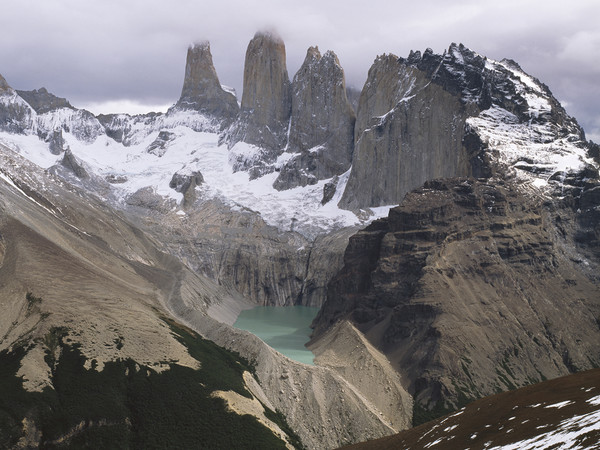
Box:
<box><xmin>340</xmin><ymin>48</ymin><xmax>476</xmax><ymax>209</ymax></box>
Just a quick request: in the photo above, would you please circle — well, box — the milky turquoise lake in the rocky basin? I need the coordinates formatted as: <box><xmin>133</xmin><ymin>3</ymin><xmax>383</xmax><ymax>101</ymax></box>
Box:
<box><xmin>233</xmin><ymin>306</ymin><xmax>319</xmax><ymax>364</ymax></box>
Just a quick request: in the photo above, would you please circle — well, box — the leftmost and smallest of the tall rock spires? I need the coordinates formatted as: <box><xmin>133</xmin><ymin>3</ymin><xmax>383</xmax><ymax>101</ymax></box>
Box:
<box><xmin>176</xmin><ymin>41</ymin><xmax>239</xmax><ymax>126</ymax></box>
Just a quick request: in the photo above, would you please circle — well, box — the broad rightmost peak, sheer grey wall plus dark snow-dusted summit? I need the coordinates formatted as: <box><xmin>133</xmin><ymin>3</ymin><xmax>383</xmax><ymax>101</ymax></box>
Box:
<box><xmin>340</xmin><ymin>44</ymin><xmax>585</xmax><ymax>209</ymax></box>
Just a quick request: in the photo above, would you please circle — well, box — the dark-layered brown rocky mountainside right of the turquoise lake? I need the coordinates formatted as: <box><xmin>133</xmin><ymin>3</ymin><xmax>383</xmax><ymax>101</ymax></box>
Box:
<box><xmin>314</xmin><ymin>179</ymin><xmax>600</xmax><ymax>418</ymax></box>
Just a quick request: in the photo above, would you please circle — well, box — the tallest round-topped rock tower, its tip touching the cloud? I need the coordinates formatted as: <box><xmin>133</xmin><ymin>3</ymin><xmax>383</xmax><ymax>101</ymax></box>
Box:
<box><xmin>222</xmin><ymin>32</ymin><xmax>292</xmax><ymax>163</ymax></box>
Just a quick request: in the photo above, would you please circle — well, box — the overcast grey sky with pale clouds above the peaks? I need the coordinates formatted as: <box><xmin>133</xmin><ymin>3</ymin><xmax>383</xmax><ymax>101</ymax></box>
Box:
<box><xmin>0</xmin><ymin>0</ymin><xmax>600</xmax><ymax>142</ymax></box>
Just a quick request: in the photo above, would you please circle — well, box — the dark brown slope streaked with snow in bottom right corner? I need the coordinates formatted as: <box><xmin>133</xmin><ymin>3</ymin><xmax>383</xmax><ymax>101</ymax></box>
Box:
<box><xmin>344</xmin><ymin>369</ymin><xmax>600</xmax><ymax>450</ymax></box>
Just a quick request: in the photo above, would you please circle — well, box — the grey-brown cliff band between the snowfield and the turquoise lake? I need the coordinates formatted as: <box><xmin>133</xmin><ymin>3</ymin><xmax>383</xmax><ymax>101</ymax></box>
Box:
<box><xmin>137</xmin><ymin>199</ymin><xmax>356</xmax><ymax>306</ymax></box>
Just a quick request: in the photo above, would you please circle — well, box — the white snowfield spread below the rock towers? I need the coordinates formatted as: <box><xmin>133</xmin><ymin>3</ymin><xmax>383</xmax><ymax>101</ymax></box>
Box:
<box><xmin>0</xmin><ymin>121</ymin><xmax>390</xmax><ymax>234</ymax></box>
